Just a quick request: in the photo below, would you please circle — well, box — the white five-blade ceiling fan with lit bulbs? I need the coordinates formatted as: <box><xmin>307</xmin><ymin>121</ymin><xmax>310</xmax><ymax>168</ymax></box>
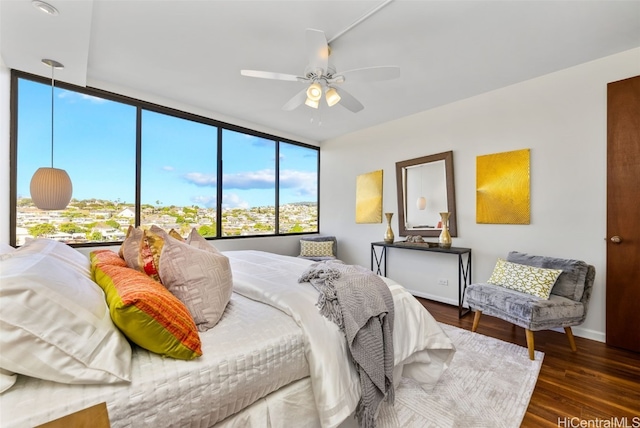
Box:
<box><xmin>240</xmin><ymin>28</ymin><xmax>400</xmax><ymax>113</ymax></box>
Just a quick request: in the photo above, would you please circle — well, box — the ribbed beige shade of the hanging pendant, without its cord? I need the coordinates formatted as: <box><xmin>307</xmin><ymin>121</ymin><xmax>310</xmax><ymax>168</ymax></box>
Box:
<box><xmin>30</xmin><ymin>167</ymin><xmax>73</xmax><ymax>210</ymax></box>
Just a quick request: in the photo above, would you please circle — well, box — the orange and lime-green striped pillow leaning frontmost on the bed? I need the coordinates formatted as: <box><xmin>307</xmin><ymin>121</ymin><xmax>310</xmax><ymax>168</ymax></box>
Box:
<box><xmin>90</xmin><ymin>249</ymin><xmax>202</xmax><ymax>360</ymax></box>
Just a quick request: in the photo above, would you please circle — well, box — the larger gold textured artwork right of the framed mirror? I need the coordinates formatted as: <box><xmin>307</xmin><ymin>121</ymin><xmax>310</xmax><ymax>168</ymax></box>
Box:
<box><xmin>476</xmin><ymin>149</ymin><xmax>531</xmax><ymax>224</ymax></box>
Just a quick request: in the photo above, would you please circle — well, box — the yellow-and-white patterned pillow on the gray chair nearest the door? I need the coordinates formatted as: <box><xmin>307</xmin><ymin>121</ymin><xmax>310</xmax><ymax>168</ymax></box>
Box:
<box><xmin>487</xmin><ymin>259</ymin><xmax>562</xmax><ymax>299</ymax></box>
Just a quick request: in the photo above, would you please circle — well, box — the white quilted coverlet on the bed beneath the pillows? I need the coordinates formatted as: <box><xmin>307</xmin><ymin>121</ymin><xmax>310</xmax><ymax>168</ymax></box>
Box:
<box><xmin>0</xmin><ymin>294</ymin><xmax>309</xmax><ymax>428</ymax></box>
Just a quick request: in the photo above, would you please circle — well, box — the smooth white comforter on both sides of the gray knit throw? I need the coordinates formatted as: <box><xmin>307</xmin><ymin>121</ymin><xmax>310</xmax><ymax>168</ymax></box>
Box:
<box><xmin>224</xmin><ymin>251</ymin><xmax>455</xmax><ymax>427</ymax></box>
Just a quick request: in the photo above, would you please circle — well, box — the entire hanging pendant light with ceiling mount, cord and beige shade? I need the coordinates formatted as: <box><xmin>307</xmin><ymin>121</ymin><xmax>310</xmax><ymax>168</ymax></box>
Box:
<box><xmin>30</xmin><ymin>59</ymin><xmax>73</xmax><ymax>210</ymax></box>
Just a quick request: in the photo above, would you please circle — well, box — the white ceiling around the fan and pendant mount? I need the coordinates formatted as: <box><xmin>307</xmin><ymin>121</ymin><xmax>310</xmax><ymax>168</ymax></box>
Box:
<box><xmin>0</xmin><ymin>0</ymin><xmax>640</xmax><ymax>142</ymax></box>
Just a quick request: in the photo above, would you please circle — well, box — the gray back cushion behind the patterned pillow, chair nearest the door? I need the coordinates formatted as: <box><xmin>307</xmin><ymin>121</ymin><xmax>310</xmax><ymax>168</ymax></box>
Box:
<box><xmin>507</xmin><ymin>251</ymin><xmax>589</xmax><ymax>302</ymax></box>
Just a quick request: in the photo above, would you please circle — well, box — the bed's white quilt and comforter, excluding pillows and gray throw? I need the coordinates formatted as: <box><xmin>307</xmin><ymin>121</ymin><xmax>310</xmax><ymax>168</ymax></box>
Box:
<box><xmin>0</xmin><ymin>242</ymin><xmax>455</xmax><ymax>427</ymax></box>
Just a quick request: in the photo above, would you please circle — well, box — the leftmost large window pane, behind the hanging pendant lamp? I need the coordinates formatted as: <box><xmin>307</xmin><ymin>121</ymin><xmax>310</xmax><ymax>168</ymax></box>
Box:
<box><xmin>12</xmin><ymin>79</ymin><xmax>136</xmax><ymax>245</ymax></box>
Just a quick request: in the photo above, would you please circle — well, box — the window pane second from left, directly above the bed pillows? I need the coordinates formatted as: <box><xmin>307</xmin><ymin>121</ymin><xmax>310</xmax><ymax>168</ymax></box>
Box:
<box><xmin>140</xmin><ymin>110</ymin><xmax>218</xmax><ymax>237</ymax></box>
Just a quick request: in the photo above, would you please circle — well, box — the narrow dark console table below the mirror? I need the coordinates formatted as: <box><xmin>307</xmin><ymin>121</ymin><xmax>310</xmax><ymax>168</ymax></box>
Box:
<box><xmin>371</xmin><ymin>242</ymin><xmax>471</xmax><ymax>318</ymax></box>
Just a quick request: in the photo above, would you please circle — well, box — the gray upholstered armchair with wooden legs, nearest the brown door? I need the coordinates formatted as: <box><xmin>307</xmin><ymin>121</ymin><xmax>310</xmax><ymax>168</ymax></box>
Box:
<box><xmin>465</xmin><ymin>251</ymin><xmax>595</xmax><ymax>360</ymax></box>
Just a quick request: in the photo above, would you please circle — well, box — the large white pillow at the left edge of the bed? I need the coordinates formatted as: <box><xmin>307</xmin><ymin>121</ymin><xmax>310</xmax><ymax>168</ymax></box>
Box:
<box><xmin>0</xmin><ymin>246</ymin><xmax>131</xmax><ymax>384</ymax></box>
